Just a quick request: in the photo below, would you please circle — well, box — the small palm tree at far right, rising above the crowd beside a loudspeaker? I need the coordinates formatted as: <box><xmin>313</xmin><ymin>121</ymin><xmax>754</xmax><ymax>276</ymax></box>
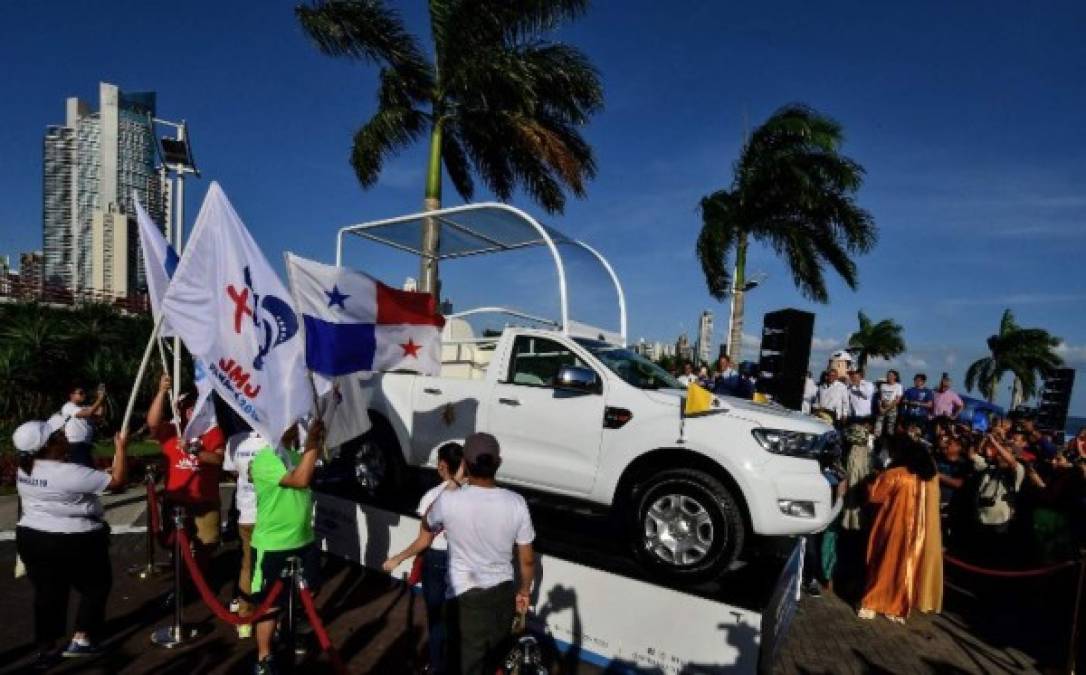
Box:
<box><xmin>965</xmin><ymin>309</ymin><xmax>1063</xmax><ymax>408</ymax></box>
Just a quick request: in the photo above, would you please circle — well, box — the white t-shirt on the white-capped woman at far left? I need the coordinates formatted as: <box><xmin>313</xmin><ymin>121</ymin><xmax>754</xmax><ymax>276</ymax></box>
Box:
<box><xmin>16</xmin><ymin>459</ymin><xmax>111</xmax><ymax>534</ymax></box>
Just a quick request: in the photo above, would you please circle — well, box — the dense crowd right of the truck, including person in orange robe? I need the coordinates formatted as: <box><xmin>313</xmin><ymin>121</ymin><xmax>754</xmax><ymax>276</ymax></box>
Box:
<box><xmin>804</xmin><ymin>369</ymin><xmax>1086</xmax><ymax>621</ymax></box>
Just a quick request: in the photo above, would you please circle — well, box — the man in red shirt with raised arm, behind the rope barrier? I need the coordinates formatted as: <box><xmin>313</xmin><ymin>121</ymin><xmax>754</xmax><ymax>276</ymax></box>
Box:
<box><xmin>147</xmin><ymin>373</ymin><xmax>226</xmax><ymax>571</ymax></box>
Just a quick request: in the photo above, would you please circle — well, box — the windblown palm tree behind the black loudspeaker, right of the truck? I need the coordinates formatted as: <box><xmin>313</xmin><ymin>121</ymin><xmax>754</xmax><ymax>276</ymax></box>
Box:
<box><xmin>697</xmin><ymin>104</ymin><xmax>877</xmax><ymax>359</ymax></box>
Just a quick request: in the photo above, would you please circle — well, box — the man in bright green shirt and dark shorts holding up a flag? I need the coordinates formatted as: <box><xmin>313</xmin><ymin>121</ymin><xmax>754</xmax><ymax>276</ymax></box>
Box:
<box><xmin>249</xmin><ymin>419</ymin><xmax>325</xmax><ymax>675</ymax></box>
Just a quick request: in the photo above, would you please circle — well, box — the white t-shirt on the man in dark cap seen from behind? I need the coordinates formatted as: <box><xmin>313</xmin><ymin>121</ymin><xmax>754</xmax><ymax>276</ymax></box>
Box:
<box><xmin>426</xmin><ymin>485</ymin><xmax>535</xmax><ymax>597</ymax></box>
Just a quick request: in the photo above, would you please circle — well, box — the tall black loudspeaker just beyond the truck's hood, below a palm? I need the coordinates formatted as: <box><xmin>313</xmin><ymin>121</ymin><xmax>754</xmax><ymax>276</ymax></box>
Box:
<box><xmin>758</xmin><ymin>309</ymin><xmax>815</xmax><ymax>410</ymax></box>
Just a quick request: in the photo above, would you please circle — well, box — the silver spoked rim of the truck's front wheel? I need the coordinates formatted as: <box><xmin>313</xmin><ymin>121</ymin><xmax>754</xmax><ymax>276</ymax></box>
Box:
<box><xmin>644</xmin><ymin>494</ymin><xmax>715</xmax><ymax>566</ymax></box>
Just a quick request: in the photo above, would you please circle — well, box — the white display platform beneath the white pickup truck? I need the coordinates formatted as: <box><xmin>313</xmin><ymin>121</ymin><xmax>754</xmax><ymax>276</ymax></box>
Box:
<box><xmin>315</xmin><ymin>493</ymin><xmax>801</xmax><ymax>674</ymax></box>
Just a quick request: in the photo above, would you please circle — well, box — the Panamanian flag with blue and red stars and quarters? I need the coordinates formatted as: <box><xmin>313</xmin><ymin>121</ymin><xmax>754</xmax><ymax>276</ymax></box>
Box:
<box><xmin>287</xmin><ymin>253</ymin><xmax>445</xmax><ymax>377</ymax></box>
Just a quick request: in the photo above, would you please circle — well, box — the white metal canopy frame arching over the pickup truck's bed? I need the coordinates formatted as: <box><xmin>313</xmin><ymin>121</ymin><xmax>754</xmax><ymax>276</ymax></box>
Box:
<box><xmin>336</xmin><ymin>202</ymin><xmax>627</xmax><ymax>346</ymax></box>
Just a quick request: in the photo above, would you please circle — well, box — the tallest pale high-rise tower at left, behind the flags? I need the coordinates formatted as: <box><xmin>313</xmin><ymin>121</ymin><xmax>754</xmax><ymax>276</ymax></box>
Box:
<box><xmin>42</xmin><ymin>82</ymin><xmax>165</xmax><ymax>297</ymax></box>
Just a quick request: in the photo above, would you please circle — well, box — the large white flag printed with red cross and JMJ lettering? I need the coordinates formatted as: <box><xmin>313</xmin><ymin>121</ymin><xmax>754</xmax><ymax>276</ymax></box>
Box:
<box><xmin>162</xmin><ymin>182</ymin><xmax>313</xmax><ymax>441</ymax></box>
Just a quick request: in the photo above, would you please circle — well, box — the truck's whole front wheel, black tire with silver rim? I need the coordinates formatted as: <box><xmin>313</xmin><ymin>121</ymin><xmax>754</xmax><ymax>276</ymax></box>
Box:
<box><xmin>628</xmin><ymin>469</ymin><xmax>746</xmax><ymax>584</ymax></box>
